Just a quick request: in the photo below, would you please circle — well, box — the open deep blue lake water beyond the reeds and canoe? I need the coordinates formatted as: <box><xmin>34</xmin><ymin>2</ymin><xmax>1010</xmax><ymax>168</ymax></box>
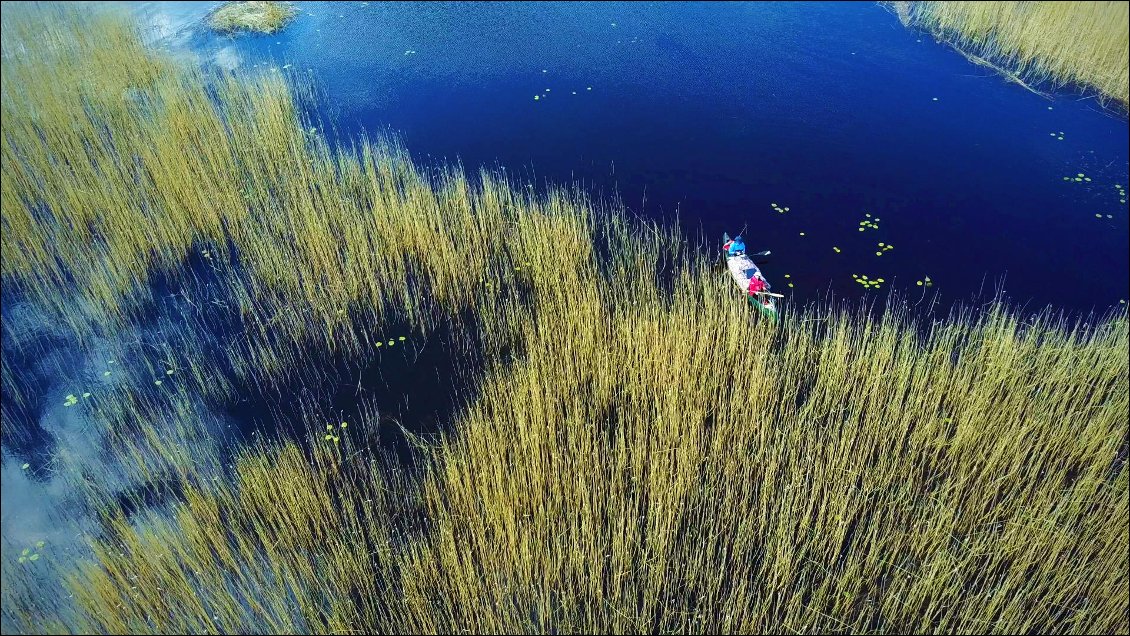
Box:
<box><xmin>136</xmin><ymin>2</ymin><xmax>1130</xmax><ymax>311</ymax></box>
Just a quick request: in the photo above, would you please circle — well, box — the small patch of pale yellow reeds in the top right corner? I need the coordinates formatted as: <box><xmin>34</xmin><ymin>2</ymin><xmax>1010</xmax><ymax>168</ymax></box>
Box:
<box><xmin>890</xmin><ymin>1</ymin><xmax>1130</xmax><ymax>108</ymax></box>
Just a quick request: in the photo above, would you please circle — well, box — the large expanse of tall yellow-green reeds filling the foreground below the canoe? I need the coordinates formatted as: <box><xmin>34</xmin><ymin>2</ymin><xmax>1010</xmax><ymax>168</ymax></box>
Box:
<box><xmin>0</xmin><ymin>9</ymin><xmax>1130</xmax><ymax>634</ymax></box>
